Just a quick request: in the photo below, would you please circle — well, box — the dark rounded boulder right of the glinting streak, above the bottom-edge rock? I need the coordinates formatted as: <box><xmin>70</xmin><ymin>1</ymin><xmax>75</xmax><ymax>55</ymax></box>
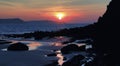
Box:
<box><xmin>61</xmin><ymin>44</ymin><xmax>79</xmax><ymax>54</ymax></box>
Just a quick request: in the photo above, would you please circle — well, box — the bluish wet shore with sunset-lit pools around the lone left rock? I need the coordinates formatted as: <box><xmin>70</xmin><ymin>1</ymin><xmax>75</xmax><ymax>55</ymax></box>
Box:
<box><xmin>0</xmin><ymin>39</ymin><xmax>89</xmax><ymax>66</ymax></box>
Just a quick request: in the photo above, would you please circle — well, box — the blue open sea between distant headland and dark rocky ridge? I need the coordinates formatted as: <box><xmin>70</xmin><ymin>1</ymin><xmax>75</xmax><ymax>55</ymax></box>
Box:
<box><xmin>0</xmin><ymin>22</ymin><xmax>88</xmax><ymax>34</ymax></box>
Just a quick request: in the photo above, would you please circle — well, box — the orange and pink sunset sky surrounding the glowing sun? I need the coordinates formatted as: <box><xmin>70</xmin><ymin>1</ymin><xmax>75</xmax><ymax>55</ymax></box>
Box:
<box><xmin>0</xmin><ymin>0</ymin><xmax>109</xmax><ymax>22</ymax></box>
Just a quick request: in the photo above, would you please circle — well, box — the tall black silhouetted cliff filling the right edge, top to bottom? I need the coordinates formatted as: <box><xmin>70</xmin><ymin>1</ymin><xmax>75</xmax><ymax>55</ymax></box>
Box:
<box><xmin>93</xmin><ymin>0</ymin><xmax>120</xmax><ymax>66</ymax></box>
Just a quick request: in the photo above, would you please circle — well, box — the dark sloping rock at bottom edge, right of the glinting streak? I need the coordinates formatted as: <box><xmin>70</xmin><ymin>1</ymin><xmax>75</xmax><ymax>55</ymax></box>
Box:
<box><xmin>62</xmin><ymin>55</ymin><xmax>85</xmax><ymax>66</ymax></box>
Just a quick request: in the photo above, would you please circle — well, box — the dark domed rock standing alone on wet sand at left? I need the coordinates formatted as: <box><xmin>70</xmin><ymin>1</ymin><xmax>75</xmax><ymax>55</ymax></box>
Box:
<box><xmin>7</xmin><ymin>43</ymin><xmax>29</xmax><ymax>51</ymax></box>
